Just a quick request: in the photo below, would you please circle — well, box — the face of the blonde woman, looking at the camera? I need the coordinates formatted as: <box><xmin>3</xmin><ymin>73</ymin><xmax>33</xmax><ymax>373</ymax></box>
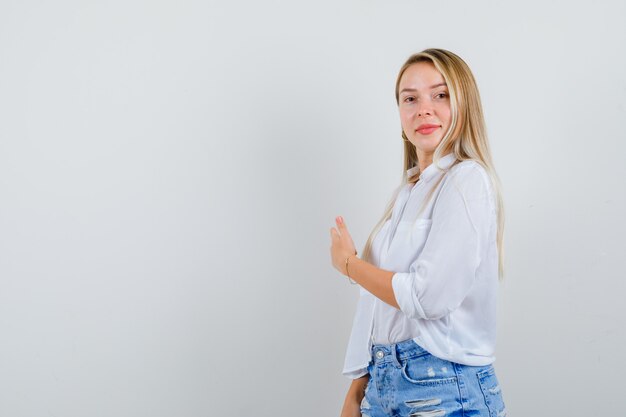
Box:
<box><xmin>398</xmin><ymin>62</ymin><xmax>451</xmax><ymax>158</ymax></box>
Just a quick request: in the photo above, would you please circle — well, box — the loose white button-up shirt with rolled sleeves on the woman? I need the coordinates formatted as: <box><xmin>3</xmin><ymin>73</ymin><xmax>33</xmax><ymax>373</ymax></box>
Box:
<box><xmin>343</xmin><ymin>154</ymin><xmax>498</xmax><ymax>378</ymax></box>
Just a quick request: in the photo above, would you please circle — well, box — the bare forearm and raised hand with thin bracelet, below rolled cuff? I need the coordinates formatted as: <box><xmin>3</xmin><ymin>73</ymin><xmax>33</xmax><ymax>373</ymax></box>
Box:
<box><xmin>330</xmin><ymin>216</ymin><xmax>400</xmax><ymax>309</ymax></box>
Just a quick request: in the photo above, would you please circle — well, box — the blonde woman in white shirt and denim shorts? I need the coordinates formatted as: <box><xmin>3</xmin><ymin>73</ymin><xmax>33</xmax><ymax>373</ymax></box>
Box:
<box><xmin>330</xmin><ymin>49</ymin><xmax>506</xmax><ymax>417</ymax></box>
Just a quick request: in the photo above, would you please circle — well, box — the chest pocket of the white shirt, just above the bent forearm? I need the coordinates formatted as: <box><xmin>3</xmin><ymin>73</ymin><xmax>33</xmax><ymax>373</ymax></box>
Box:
<box><xmin>386</xmin><ymin>219</ymin><xmax>432</xmax><ymax>272</ymax></box>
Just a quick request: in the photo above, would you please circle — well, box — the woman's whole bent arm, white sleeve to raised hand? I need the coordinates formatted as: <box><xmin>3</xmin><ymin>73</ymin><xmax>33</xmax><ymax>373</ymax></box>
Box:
<box><xmin>331</xmin><ymin>164</ymin><xmax>496</xmax><ymax>319</ymax></box>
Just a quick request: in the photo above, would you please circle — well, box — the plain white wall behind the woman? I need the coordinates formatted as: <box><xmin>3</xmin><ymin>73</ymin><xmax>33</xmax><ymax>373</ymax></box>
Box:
<box><xmin>0</xmin><ymin>0</ymin><xmax>626</xmax><ymax>417</ymax></box>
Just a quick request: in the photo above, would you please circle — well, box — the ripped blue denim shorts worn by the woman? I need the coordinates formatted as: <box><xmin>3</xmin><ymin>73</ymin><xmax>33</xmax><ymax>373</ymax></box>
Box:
<box><xmin>361</xmin><ymin>340</ymin><xmax>506</xmax><ymax>417</ymax></box>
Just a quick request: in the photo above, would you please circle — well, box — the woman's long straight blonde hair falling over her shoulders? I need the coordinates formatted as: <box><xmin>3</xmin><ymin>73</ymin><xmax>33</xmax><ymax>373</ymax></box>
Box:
<box><xmin>362</xmin><ymin>49</ymin><xmax>504</xmax><ymax>278</ymax></box>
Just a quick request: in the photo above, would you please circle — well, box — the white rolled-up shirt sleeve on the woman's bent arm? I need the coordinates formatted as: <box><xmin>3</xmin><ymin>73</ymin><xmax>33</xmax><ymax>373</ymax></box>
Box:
<box><xmin>392</xmin><ymin>163</ymin><xmax>496</xmax><ymax>320</ymax></box>
